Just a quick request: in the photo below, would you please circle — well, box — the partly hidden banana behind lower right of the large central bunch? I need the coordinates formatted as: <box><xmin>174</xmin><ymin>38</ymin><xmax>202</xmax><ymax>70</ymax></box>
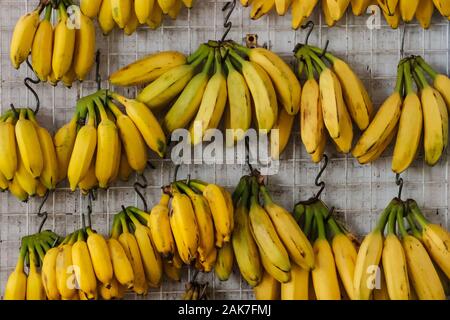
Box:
<box><xmin>270</xmin><ymin>108</ymin><xmax>295</xmax><ymax>159</ymax></box>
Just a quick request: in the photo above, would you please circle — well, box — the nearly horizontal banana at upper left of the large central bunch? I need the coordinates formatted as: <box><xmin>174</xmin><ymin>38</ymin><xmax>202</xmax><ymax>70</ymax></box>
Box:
<box><xmin>109</xmin><ymin>51</ymin><xmax>186</xmax><ymax>86</ymax></box>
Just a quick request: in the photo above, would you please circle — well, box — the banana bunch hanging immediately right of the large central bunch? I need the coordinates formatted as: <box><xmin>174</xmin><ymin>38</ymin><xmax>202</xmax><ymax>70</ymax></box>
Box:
<box><xmin>295</xmin><ymin>45</ymin><xmax>373</xmax><ymax>162</ymax></box>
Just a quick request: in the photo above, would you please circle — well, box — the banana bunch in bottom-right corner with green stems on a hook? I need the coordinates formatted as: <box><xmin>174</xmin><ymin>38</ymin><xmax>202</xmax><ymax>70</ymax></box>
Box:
<box><xmin>353</xmin><ymin>199</ymin><xmax>450</xmax><ymax>300</ymax></box>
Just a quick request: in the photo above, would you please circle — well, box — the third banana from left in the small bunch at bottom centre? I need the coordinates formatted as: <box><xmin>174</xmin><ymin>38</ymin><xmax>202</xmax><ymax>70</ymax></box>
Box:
<box><xmin>177</xmin><ymin>182</ymin><xmax>215</xmax><ymax>261</ymax></box>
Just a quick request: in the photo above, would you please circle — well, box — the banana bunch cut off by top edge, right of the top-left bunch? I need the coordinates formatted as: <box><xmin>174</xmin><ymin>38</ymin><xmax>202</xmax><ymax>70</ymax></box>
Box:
<box><xmin>92</xmin><ymin>0</ymin><xmax>193</xmax><ymax>36</ymax></box>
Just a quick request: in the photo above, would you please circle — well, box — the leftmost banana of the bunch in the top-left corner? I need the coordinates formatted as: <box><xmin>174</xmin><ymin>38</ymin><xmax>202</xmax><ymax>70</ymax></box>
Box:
<box><xmin>9</xmin><ymin>6</ymin><xmax>42</xmax><ymax>69</ymax></box>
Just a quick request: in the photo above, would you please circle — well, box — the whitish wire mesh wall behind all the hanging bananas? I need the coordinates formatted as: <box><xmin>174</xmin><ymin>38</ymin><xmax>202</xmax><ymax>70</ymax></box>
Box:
<box><xmin>0</xmin><ymin>0</ymin><xmax>450</xmax><ymax>299</ymax></box>
